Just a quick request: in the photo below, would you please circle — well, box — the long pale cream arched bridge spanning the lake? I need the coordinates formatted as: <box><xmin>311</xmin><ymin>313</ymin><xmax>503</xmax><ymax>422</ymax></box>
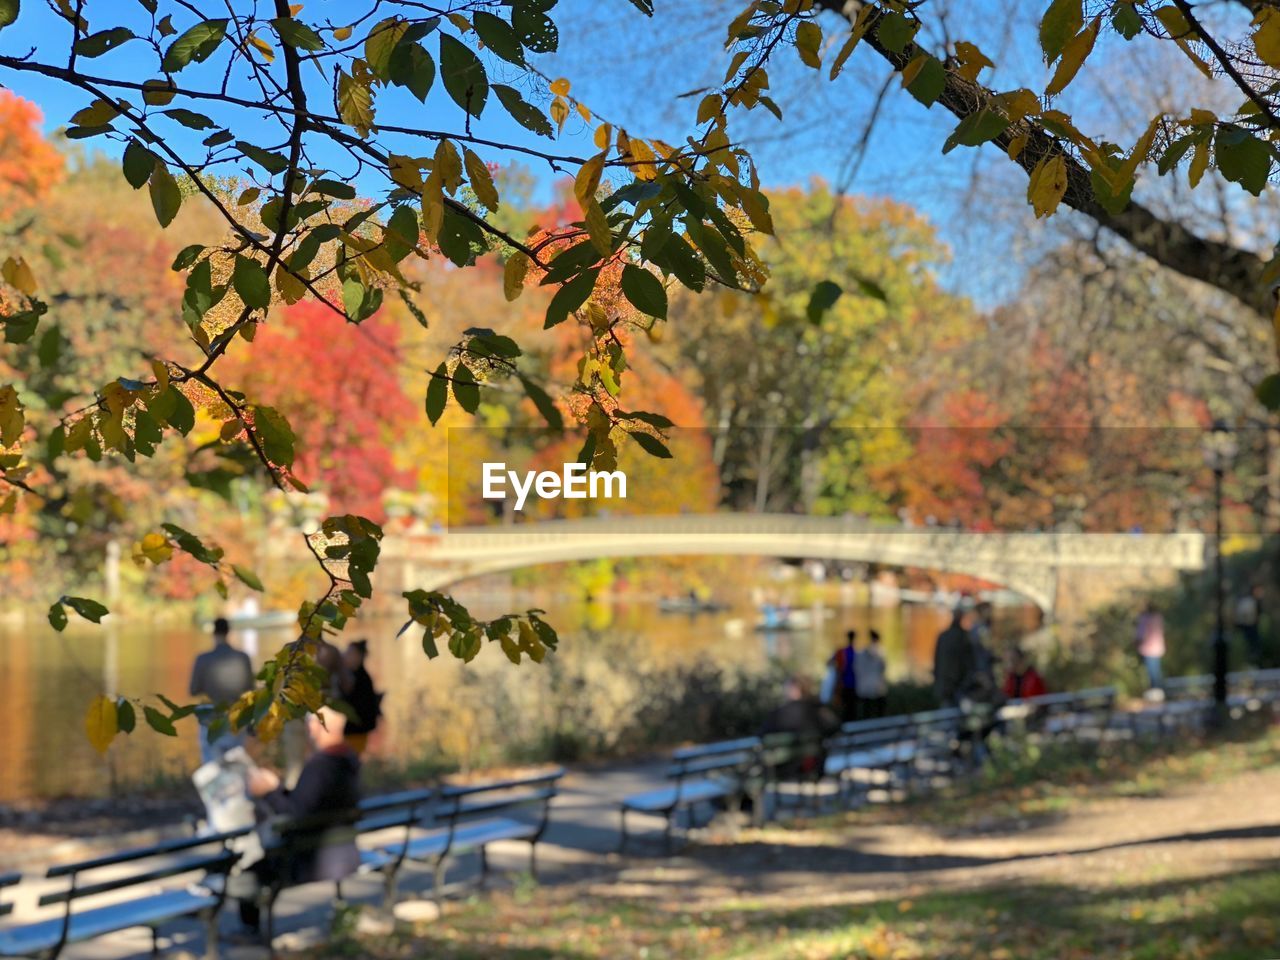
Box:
<box><xmin>379</xmin><ymin>513</ymin><xmax>1204</xmax><ymax>613</ymax></box>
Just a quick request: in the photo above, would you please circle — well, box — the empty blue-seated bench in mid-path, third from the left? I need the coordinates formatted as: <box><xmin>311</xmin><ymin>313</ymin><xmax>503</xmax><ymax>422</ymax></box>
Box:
<box><xmin>618</xmin><ymin>737</ymin><xmax>760</xmax><ymax>852</ymax></box>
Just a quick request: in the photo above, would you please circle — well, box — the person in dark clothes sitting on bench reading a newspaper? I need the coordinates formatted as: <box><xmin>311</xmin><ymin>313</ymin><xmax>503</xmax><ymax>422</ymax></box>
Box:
<box><xmin>233</xmin><ymin>707</ymin><xmax>360</xmax><ymax>937</ymax></box>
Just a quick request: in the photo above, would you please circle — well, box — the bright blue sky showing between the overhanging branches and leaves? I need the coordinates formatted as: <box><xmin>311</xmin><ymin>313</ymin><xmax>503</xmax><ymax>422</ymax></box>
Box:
<box><xmin>0</xmin><ymin>0</ymin><xmax>1198</xmax><ymax>303</ymax></box>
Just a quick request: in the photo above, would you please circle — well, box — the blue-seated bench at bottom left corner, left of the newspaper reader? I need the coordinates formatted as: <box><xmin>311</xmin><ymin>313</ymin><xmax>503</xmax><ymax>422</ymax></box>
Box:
<box><xmin>0</xmin><ymin>833</ymin><xmax>239</xmax><ymax>960</ymax></box>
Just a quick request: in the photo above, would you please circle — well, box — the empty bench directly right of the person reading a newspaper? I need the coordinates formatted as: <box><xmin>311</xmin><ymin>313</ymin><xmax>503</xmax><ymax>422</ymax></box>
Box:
<box><xmin>373</xmin><ymin>767</ymin><xmax>564</xmax><ymax>897</ymax></box>
